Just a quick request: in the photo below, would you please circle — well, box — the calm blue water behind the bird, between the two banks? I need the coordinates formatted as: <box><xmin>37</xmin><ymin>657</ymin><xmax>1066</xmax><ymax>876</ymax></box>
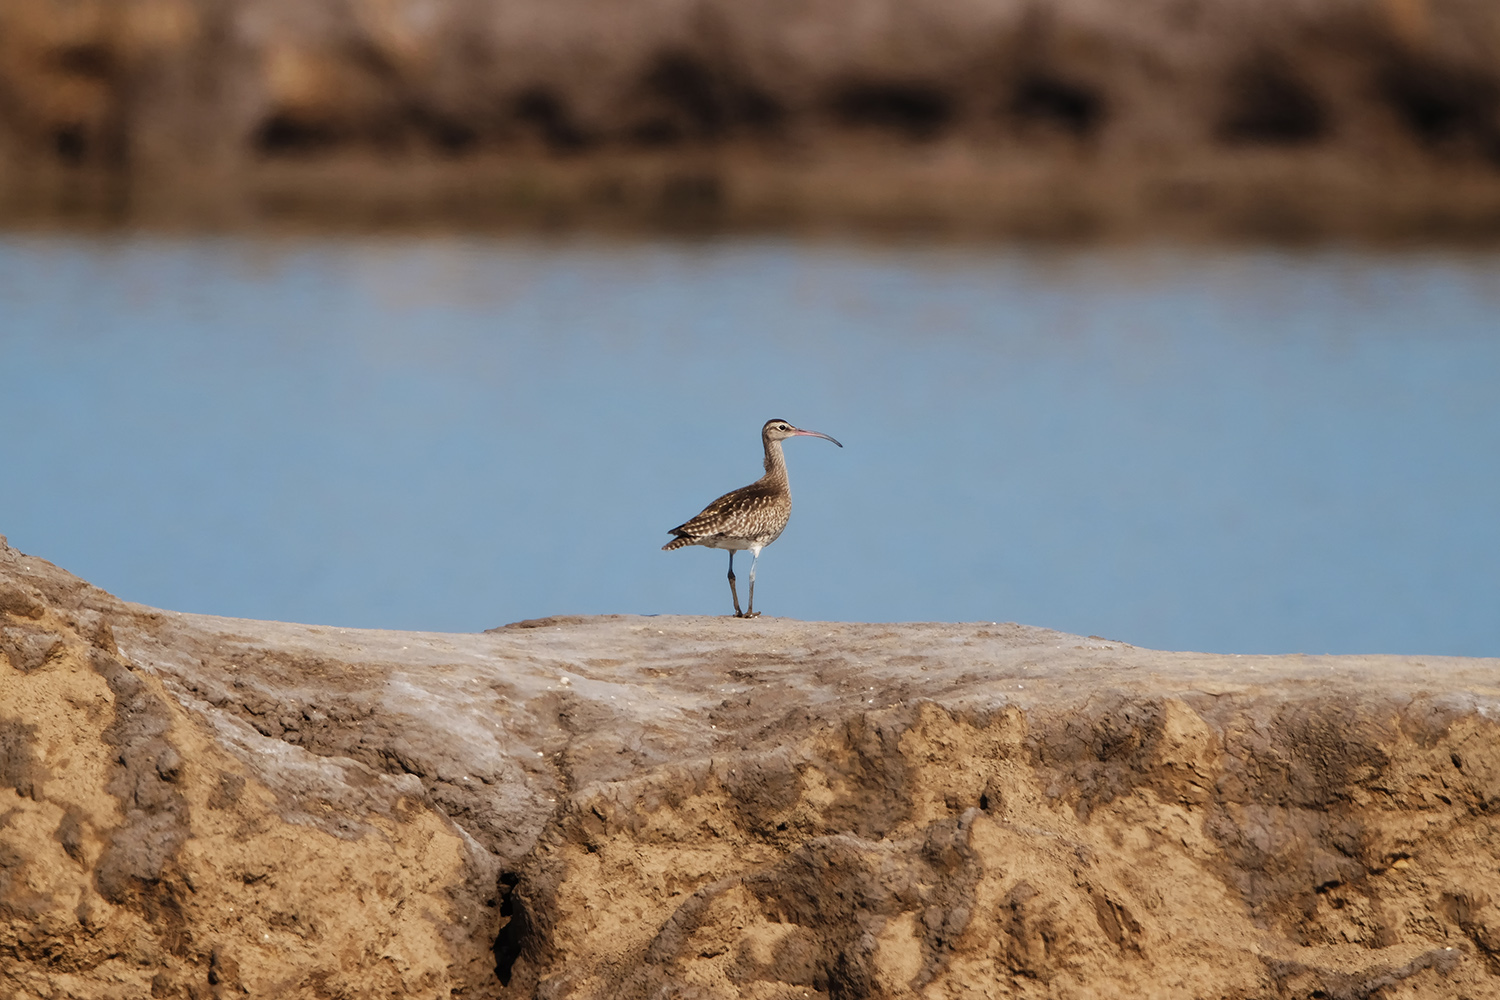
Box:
<box><xmin>0</xmin><ymin>234</ymin><xmax>1500</xmax><ymax>655</ymax></box>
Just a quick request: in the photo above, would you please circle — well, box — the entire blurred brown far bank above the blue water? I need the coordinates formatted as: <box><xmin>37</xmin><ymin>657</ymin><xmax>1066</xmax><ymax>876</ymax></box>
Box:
<box><xmin>0</xmin><ymin>0</ymin><xmax>1500</xmax><ymax>238</ymax></box>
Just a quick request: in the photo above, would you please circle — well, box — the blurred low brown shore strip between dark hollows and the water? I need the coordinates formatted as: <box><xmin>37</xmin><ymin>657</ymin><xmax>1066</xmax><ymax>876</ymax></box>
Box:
<box><xmin>11</xmin><ymin>147</ymin><xmax>1500</xmax><ymax>244</ymax></box>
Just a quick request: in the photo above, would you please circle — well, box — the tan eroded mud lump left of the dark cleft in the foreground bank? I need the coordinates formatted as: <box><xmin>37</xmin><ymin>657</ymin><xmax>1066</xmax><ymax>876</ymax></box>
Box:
<box><xmin>0</xmin><ymin>550</ymin><xmax>495</xmax><ymax>1000</ymax></box>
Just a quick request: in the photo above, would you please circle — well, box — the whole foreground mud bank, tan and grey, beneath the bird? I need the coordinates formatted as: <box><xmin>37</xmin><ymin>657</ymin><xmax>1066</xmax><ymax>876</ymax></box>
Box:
<box><xmin>0</xmin><ymin>547</ymin><xmax>1500</xmax><ymax>999</ymax></box>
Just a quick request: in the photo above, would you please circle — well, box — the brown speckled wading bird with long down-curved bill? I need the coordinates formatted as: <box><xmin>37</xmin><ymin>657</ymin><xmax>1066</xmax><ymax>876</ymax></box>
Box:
<box><xmin>662</xmin><ymin>420</ymin><xmax>843</xmax><ymax>618</ymax></box>
